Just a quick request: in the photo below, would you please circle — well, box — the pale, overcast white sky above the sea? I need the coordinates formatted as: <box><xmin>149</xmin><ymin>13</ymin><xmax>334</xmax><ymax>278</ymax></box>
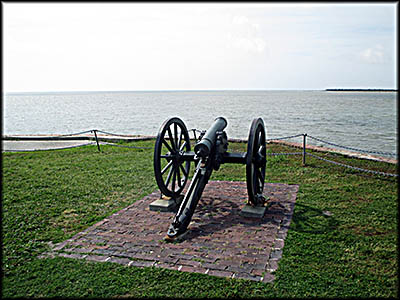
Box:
<box><xmin>2</xmin><ymin>2</ymin><xmax>397</xmax><ymax>92</ymax></box>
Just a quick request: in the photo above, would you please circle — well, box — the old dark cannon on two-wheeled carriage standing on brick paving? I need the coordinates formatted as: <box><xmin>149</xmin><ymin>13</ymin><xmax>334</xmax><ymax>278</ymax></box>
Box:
<box><xmin>154</xmin><ymin>117</ymin><xmax>266</xmax><ymax>241</ymax></box>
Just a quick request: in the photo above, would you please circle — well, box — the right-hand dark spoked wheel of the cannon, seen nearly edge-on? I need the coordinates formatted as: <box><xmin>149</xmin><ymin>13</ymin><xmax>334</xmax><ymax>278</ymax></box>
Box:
<box><xmin>246</xmin><ymin>118</ymin><xmax>267</xmax><ymax>206</ymax></box>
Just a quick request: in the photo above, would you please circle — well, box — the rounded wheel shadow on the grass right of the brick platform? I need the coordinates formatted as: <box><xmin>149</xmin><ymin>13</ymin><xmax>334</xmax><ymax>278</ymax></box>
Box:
<box><xmin>290</xmin><ymin>203</ymin><xmax>339</xmax><ymax>234</ymax></box>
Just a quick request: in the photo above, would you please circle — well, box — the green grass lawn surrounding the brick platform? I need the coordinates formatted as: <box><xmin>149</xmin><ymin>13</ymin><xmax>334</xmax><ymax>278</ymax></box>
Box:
<box><xmin>2</xmin><ymin>141</ymin><xmax>398</xmax><ymax>298</ymax></box>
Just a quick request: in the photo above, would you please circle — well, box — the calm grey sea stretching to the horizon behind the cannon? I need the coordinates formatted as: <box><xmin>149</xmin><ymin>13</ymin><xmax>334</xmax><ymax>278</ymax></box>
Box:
<box><xmin>3</xmin><ymin>91</ymin><xmax>397</xmax><ymax>157</ymax></box>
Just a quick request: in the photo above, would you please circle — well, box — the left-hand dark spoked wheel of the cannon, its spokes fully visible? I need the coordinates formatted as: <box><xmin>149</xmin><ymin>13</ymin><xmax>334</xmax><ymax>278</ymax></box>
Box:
<box><xmin>154</xmin><ymin>117</ymin><xmax>190</xmax><ymax>198</ymax></box>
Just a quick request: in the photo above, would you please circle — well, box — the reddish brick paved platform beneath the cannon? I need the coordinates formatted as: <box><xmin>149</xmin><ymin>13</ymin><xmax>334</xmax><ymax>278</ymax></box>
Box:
<box><xmin>41</xmin><ymin>181</ymin><xmax>298</xmax><ymax>282</ymax></box>
